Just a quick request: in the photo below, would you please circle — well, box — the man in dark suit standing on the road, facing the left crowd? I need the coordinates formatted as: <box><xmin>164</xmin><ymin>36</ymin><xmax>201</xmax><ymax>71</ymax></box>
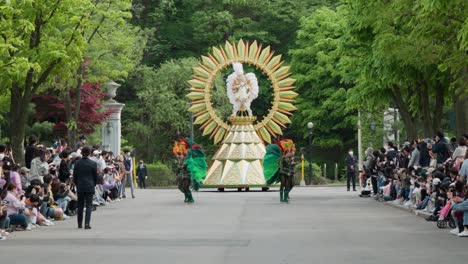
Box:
<box><xmin>73</xmin><ymin>146</ymin><xmax>98</xmax><ymax>229</ymax></box>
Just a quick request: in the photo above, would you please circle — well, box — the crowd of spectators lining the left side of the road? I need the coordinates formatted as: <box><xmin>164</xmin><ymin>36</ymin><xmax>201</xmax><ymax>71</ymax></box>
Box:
<box><xmin>0</xmin><ymin>136</ymin><xmax>146</xmax><ymax>240</ymax></box>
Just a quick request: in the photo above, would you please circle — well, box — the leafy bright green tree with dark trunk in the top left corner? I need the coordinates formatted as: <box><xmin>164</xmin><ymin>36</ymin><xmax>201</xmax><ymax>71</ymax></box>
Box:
<box><xmin>0</xmin><ymin>0</ymin><xmax>91</xmax><ymax>163</ymax></box>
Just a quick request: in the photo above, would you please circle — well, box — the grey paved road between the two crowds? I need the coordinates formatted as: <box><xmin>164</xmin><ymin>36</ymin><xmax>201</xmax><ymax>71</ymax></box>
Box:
<box><xmin>0</xmin><ymin>187</ymin><xmax>468</xmax><ymax>264</ymax></box>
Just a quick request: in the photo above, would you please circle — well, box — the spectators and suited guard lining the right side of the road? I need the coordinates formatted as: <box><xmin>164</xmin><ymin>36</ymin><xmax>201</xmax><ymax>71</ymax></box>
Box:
<box><xmin>354</xmin><ymin>132</ymin><xmax>468</xmax><ymax>237</ymax></box>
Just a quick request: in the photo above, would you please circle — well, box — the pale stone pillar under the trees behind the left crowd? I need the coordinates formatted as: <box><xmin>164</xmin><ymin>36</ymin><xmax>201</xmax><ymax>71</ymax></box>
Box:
<box><xmin>102</xmin><ymin>81</ymin><xmax>125</xmax><ymax>155</ymax></box>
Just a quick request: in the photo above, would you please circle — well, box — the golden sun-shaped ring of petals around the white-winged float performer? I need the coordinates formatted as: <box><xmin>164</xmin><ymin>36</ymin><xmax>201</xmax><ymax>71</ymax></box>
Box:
<box><xmin>187</xmin><ymin>40</ymin><xmax>298</xmax><ymax>144</ymax></box>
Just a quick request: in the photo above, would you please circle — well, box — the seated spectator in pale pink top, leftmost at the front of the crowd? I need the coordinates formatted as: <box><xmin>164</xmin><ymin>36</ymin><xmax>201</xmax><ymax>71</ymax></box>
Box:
<box><xmin>3</xmin><ymin>183</ymin><xmax>31</xmax><ymax>230</ymax></box>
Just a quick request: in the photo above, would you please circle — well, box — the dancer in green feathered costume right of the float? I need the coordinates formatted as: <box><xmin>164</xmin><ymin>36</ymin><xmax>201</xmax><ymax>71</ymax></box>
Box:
<box><xmin>263</xmin><ymin>139</ymin><xmax>296</xmax><ymax>203</ymax></box>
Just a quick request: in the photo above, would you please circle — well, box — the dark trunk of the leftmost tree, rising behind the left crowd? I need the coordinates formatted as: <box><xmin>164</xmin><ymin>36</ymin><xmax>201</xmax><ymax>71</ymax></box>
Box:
<box><xmin>10</xmin><ymin>83</ymin><xmax>31</xmax><ymax>166</ymax></box>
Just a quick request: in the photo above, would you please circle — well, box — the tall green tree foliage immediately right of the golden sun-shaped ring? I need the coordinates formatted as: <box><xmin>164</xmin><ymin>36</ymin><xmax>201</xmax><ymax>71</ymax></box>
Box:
<box><xmin>290</xmin><ymin>7</ymin><xmax>355</xmax><ymax>148</ymax></box>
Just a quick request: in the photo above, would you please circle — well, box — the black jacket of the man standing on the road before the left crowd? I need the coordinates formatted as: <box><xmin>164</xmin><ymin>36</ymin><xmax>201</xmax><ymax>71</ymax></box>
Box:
<box><xmin>73</xmin><ymin>157</ymin><xmax>97</xmax><ymax>193</ymax></box>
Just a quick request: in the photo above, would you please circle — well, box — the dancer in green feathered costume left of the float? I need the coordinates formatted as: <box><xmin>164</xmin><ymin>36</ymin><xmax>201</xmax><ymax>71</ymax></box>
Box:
<box><xmin>173</xmin><ymin>138</ymin><xmax>208</xmax><ymax>203</ymax></box>
